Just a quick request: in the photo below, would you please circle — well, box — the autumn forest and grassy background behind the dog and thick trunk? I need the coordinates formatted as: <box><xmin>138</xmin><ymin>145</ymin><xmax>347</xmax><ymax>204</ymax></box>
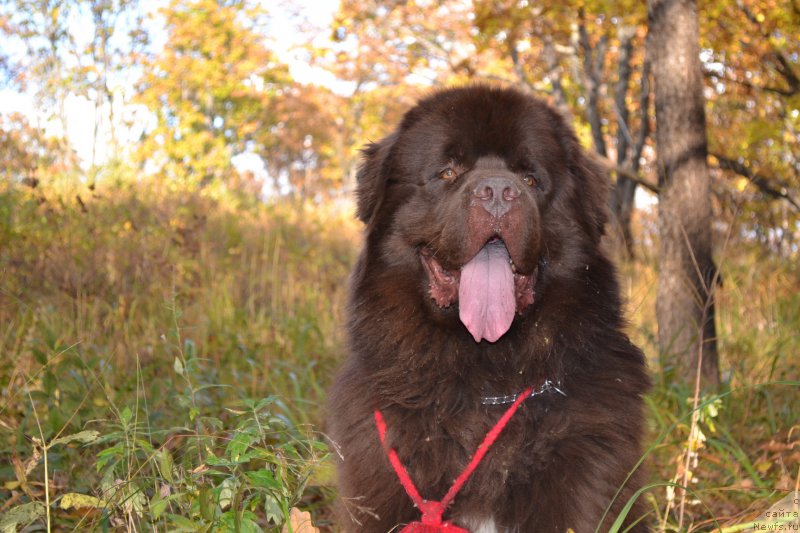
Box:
<box><xmin>0</xmin><ymin>0</ymin><xmax>800</xmax><ymax>532</ymax></box>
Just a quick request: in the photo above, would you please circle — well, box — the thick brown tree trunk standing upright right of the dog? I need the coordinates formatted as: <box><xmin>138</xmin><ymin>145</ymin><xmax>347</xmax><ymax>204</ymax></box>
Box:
<box><xmin>647</xmin><ymin>0</ymin><xmax>719</xmax><ymax>386</ymax></box>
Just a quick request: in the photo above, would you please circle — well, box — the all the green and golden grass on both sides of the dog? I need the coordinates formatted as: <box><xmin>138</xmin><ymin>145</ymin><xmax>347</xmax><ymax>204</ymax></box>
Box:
<box><xmin>0</xmin><ymin>177</ymin><xmax>800</xmax><ymax>532</ymax></box>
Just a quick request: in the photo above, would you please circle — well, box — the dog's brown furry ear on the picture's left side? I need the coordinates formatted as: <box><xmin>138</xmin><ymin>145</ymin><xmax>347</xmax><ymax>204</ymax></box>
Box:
<box><xmin>356</xmin><ymin>133</ymin><xmax>397</xmax><ymax>224</ymax></box>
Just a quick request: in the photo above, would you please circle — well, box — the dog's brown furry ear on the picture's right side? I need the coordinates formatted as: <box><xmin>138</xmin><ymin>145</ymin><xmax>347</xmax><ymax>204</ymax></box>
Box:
<box><xmin>564</xmin><ymin>132</ymin><xmax>611</xmax><ymax>243</ymax></box>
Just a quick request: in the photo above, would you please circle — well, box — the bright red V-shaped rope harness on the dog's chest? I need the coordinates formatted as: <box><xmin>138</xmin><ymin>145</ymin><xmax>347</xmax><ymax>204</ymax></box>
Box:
<box><xmin>375</xmin><ymin>388</ymin><xmax>533</xmax><ymax>533</ymax></box>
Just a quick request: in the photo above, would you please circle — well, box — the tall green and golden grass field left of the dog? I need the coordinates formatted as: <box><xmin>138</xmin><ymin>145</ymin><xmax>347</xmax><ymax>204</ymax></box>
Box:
<box><xmin>0</xmin><ymin>178</ymin><xmax>358</xmax><ymax>530</ymax></box>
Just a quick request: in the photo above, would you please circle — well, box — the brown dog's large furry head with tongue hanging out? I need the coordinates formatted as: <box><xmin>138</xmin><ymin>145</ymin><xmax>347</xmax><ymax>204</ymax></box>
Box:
<box><xmin>358</xmin><ymin>83</ymin><xmax>607</xmax><ymax>342</ymax></box>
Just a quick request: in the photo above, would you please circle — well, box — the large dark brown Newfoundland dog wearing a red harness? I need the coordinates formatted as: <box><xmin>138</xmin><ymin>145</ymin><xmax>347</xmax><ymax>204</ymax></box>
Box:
<box><xmin>329</xmin><ymin>86</ymin><xmax>649</xmax><ymax>533</ymax></box>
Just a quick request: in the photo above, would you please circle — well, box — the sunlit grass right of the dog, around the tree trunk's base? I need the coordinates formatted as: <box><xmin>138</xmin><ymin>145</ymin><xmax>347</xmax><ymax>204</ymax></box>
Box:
<box><xmin>621</xmin><ymin>214</ymin><xmax>800</xmax><ymax>531</ymax></box>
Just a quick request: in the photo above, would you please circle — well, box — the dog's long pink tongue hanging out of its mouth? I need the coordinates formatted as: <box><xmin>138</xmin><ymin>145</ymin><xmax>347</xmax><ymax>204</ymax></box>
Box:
<box><xmin>458</xmin><ymin>241</ymin><xmax>516</xmax><ymax>342</ymax></box>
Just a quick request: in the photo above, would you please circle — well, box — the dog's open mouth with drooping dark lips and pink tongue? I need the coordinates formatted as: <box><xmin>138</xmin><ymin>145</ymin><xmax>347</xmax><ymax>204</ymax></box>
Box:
<box><xmin>420</xmin><ymin>237</ymin><xmax>538</xmax><ymax>342</ymax></box>
